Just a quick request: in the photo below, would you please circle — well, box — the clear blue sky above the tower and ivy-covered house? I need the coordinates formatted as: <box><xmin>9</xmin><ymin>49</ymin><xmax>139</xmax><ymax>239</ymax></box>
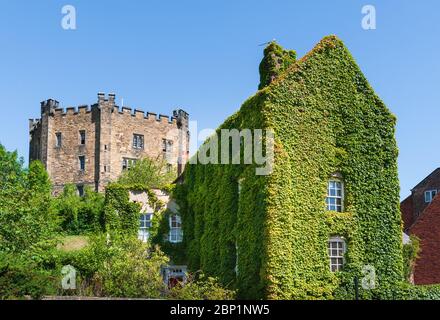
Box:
<box><xmin>0</xmin><ymin>0</ymin><xmax>440</xmax><ymax>196</ymax></box>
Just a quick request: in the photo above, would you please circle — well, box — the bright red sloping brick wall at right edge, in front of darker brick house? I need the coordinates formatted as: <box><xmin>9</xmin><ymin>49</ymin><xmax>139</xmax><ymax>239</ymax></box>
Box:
<box><xmin>410</xmin><ymin>195</ymin><xmax>440</xmax><ymax>284</ymax></box>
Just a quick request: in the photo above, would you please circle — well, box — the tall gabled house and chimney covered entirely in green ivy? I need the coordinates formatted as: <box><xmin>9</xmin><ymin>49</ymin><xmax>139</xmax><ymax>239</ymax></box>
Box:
<box><xmin>168</xmin><ymin>36</ymin><xmax>403</xmax><ymax>299</ymax></box>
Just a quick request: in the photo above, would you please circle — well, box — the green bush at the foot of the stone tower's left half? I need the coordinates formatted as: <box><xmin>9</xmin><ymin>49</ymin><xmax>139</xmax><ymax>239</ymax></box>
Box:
<box><xmin>55</xmin><ymin>184</ymin><xmax>104</xmax><ymax>234</ymax></box>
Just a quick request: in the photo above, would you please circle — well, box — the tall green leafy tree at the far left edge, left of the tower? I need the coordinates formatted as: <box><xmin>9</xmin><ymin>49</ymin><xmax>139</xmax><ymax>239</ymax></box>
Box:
<box><xmin>0</xmin><ymin>145</ymin><xmax>57</xmax><ymax>253</ymax></box>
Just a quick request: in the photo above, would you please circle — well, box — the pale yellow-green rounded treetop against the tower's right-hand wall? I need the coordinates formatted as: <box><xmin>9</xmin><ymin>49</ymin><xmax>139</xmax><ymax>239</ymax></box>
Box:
<box><xmin>117</xmin><ymin>157</ymin><xmax>176</xmax><ymax>189</ymax></box>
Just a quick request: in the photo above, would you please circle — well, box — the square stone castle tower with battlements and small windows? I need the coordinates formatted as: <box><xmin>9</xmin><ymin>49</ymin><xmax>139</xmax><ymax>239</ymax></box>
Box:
<box><xmin>29</xmin><ymin>93</ymin><xmax>189</xmax><ymax>194</ymax></box>
